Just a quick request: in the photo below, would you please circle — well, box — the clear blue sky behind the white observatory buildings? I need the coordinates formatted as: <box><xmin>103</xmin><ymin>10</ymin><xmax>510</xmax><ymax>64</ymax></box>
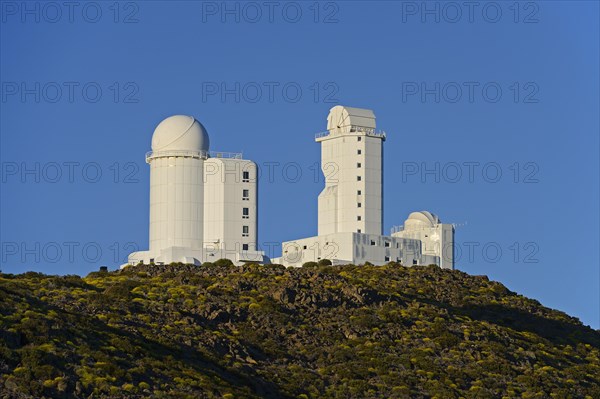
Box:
<box><xmin>0</xmin><ymin>1</ymin><xmax>600</xmax><ymax>328</ymax></box>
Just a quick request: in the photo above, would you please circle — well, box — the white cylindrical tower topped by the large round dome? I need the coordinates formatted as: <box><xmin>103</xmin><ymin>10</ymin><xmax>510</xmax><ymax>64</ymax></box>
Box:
<box><xmin>146</xmin><ymin>115</ymin><xmax>209</xmax><ymax>253</ymax></box>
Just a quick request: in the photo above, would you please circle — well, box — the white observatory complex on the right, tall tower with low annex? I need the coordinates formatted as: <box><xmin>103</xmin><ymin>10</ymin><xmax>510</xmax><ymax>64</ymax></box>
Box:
<box><xmin>272</xmin><ymin>105</ymin><xmax>454</xmax><ymax>269</ymax></box>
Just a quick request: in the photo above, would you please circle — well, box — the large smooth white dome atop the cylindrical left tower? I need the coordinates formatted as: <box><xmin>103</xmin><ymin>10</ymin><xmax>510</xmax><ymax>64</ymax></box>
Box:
<box><xmin>152</xmin><ymin>115</ymin><xmax>209</xmax><ymax>152</ymax></box>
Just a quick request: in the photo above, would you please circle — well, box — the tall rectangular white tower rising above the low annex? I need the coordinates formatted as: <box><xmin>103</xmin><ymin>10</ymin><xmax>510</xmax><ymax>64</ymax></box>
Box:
<box><xmin>315</xmin><ymin>105</ymin><xmax>385</xmax><ymax>236</ymax></box>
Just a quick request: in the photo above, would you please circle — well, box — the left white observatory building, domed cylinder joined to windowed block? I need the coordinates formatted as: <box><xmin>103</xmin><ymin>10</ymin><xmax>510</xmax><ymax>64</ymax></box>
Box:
<box><xmin>124</xmin><ymin>115</ymin><xmax>264</xmax><ymax>266</ymax></box>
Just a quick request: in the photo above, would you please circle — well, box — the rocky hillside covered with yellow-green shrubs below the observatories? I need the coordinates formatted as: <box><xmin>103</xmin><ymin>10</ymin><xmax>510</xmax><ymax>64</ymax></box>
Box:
<box><xmin>0</xmin><ymin>262</ymin><xmax>600</xmax><ymax>399</ymax></box>
